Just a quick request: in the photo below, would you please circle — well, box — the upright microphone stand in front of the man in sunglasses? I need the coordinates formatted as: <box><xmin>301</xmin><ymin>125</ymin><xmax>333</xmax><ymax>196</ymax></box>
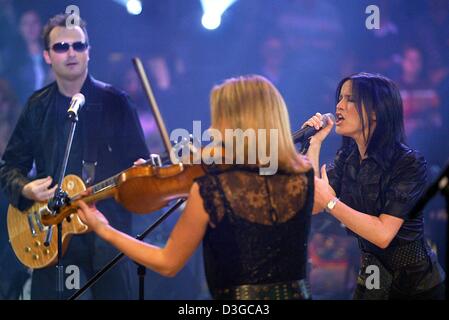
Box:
<box><xmin>44</xmin><ymin>113</ymin><xmax>78</xmax><ymax>300</ymax></box>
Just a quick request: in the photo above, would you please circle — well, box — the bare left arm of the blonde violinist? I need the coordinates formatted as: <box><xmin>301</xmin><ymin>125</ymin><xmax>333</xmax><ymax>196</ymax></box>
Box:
<box><xmin>78</xmin><ymin>183</ymin><xmax>209</xmax><ymax>277</ymax></box>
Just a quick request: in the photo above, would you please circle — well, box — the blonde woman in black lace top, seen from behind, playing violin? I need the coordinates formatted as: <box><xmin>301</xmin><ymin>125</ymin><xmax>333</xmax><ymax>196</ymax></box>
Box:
<box><xmin>78</xmin><ymin>76</ymin><xmax>314</xmax><ymax>299</ymax></box>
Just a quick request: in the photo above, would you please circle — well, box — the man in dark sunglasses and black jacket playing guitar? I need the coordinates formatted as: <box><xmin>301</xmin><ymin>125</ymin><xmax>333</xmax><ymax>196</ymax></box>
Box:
<box><xmin>0</xmin><ymin>14</ymin><xmax>149</xmax><ymax>299</ymax></box>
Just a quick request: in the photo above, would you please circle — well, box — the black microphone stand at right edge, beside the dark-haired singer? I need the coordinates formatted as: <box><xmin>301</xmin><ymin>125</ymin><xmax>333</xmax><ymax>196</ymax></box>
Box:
<box><xmin>410</xmin><ymin>162</ymin><xmax>449</xmax><ymax>300</ymax></box>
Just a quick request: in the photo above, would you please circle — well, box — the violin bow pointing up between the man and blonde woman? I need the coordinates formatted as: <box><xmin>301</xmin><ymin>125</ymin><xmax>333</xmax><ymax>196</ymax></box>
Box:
<box><xmin>132</xmin><ymin>57</ymin><xmax>172</xmax><ymax>161</ymax></box>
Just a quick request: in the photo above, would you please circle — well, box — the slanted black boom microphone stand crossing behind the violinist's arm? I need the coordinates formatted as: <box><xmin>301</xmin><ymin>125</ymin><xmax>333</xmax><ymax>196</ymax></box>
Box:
<box><xmin>68</xmin><ymin>199</ymin><xmax>186</xmax><ymax>300</ymax></box>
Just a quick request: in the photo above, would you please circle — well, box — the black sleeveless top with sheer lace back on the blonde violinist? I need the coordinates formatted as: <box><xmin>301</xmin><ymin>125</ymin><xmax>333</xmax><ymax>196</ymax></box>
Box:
<box><xmin>196</xmin><ymin>166</ymin><xmax>313</xmax><ymax>298</ymax></box>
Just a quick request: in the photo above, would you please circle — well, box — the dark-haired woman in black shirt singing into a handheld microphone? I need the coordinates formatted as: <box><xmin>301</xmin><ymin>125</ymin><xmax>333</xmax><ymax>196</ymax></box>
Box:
<box><xmin>305</xmin><ymin>73</ymin><xmax>445</xmax><ymax>299</ymax></box>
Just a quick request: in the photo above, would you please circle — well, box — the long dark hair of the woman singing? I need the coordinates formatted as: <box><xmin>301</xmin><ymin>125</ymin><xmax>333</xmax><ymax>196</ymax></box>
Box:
<box><xmin>336</xmin><ymin>72</ymin><xmax>405</xmax><ymax>160</ymax></box>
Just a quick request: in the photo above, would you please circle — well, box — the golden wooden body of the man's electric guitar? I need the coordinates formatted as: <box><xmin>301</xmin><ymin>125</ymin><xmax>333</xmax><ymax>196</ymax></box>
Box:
<box><xmin>7</xmin><ymin>175</ymin><xmax>88</xmax><ymax>269</ymax></box>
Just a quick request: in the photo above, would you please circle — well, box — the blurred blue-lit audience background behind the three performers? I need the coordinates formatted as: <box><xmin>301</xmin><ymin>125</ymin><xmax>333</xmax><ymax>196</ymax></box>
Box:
<box><xmin>0</xmin><ymin>0</ymin><xmax>449</xmax><ymax>298</ymax></box>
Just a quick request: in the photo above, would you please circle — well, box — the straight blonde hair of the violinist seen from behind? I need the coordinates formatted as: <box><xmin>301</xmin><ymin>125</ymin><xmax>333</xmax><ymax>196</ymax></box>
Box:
<box><xmin>210</xmin><ymin>75</ymin><xmax>310</xmax><ymax>172</ymax></box>
